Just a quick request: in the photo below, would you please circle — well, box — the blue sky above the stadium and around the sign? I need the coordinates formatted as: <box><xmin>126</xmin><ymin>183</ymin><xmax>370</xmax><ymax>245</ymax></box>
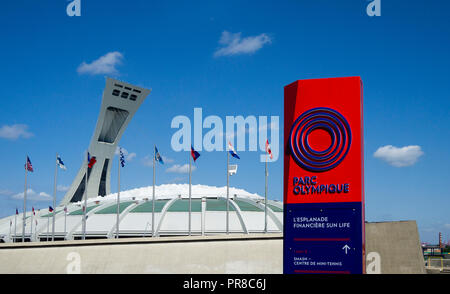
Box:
<box><xmin>0</xmin><ymin>0</ymin><xmax>450</xmax><ymax>243</ymax></box>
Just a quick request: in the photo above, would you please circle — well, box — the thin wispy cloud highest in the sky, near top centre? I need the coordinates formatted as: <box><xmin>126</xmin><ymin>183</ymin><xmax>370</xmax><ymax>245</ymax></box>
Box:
<box><xmin>214</xmin><ymin>31</ymin><xmax>272</xmax><ymax>57</ymax></box>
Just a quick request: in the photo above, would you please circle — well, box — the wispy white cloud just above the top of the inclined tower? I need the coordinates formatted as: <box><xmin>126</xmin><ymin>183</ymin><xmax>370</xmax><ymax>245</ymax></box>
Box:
<box><xmin>77</xmin><ymin>51</ymin><xmax>123</xmax><ymax>75</ymax></box>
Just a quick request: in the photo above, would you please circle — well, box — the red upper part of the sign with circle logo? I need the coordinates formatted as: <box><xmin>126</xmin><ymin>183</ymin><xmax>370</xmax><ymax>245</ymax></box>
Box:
<box><xmin>284</xmin><ymin>77</ymin><xmax>364</xmax><ymax>204</ymax></box>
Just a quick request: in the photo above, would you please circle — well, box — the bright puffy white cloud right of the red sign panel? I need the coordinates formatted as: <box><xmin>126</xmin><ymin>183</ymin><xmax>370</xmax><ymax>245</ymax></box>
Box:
<box><xmin>373</xmin><ymin>145</ymin><xmax>424</xmax><ymax>167</ymax></box>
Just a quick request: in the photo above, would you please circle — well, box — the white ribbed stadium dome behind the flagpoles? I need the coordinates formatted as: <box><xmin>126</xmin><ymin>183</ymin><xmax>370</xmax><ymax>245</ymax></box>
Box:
<box><xmin>0</xmin><ymin>184</ymin><xmax>283</xmax><ymax>243</ymax></box>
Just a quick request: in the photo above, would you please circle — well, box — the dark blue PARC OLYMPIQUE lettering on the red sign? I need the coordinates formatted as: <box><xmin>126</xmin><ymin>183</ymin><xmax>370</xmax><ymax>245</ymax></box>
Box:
<box><xmin>292</xmin><ymin>176</ymin><xmax>350</xmax><ymax>195</ymax></box>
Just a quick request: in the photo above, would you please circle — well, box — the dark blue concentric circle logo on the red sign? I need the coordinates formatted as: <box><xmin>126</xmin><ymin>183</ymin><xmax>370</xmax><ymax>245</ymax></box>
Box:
<box><xmin>289</xmin><ymin>107</ymin><xmax>352</xmax><ymax>172</ymax></box>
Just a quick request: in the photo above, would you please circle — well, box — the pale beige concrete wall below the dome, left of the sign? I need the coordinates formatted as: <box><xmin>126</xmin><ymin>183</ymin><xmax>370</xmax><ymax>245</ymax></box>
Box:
<box><xmin>0</xmin><ymin>234</ymin><xmax>283</xmax><ymax>274</ymax></box>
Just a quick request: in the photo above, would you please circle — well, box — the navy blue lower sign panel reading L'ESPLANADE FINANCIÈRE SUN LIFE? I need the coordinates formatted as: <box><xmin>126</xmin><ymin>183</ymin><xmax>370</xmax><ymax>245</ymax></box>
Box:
<box><xmin>283</xmin><ymin>202</ymin><xmax>364</xmax><ymax>274</ymax></box>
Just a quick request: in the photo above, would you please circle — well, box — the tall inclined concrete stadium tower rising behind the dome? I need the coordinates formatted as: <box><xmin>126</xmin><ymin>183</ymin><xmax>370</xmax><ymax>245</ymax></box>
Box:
<box><xmin>60</xmin><ymin>78</ymin><xmax>150</xmax><ymax>205</ymax></box>
